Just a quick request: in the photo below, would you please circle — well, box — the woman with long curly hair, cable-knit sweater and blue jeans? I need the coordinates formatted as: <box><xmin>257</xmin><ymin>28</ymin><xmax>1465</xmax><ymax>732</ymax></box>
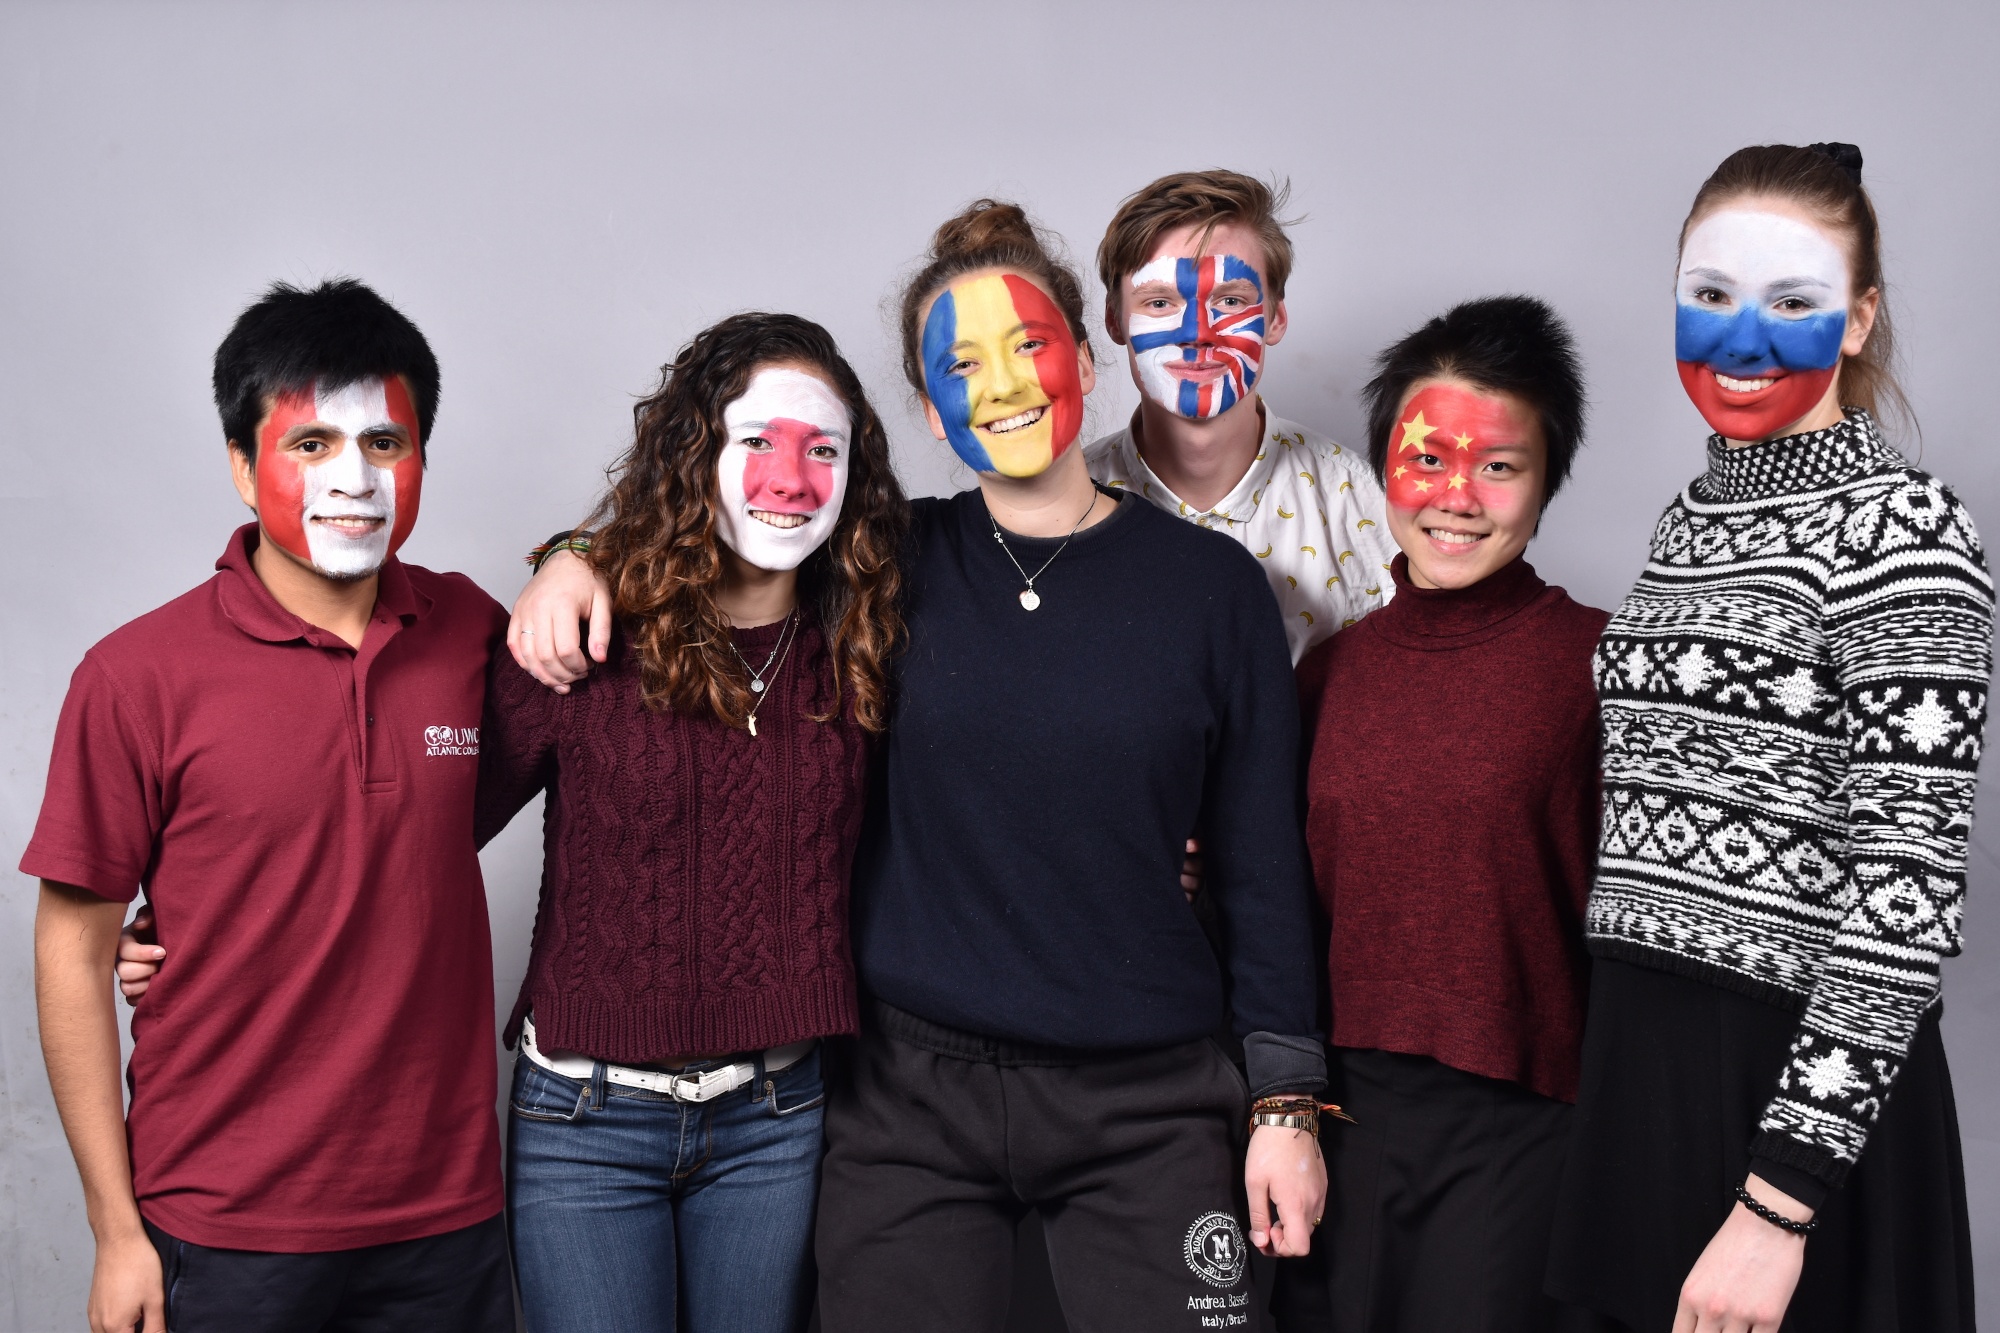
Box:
<box><xmin>460</xmin><ymin>314</ymin><xmax>908</xmax><ymax>1333</ymax></box>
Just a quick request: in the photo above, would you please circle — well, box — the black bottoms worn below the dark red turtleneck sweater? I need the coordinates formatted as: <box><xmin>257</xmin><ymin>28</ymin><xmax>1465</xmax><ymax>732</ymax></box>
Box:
<box><xmin>1272</xmin><ymin>1049</ymin><xmax>1608</xmax><ymax>1333</ymax></box>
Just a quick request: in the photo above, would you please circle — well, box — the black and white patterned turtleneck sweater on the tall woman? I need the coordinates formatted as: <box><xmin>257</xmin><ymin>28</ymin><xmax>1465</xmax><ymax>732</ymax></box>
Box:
<box><xmin>1584</xmin><ymin>408</ymin><xmax>1994</xmax><ymax>1185</ymax></box>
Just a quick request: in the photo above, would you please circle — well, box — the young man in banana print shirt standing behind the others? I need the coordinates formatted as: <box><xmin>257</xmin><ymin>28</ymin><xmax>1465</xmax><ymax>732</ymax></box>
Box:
<box><xmin>1086</xmin><ymin>170</ymin><xmax>1396</xmax><ymax>660</ymax></box>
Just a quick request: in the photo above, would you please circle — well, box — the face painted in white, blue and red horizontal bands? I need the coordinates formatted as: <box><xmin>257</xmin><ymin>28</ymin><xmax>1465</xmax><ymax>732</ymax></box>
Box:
<box><xmin>1674</xmin><ymin>208</ymin><xmax>1850</xmax><ymax>440</ymax></box>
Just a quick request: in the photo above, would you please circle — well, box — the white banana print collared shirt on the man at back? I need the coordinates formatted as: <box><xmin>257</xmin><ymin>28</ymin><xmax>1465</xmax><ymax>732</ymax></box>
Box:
<box><xmin>1084</xmin><ymin>404</ymin><xmax>1396</xmax><ymax>664</ymax></box>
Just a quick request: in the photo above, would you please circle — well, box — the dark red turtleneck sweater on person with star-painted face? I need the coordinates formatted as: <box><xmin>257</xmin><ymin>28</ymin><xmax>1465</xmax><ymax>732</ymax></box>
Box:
<box><xmin>1298</xmin><ymin>556</ymin><xmax>1606</xmax><ymax>1101</ymax></box>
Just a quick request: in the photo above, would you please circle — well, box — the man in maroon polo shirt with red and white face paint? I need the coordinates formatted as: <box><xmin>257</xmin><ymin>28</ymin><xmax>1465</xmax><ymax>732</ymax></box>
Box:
<box><xmin>22</xmin><ymin>280</ymin><xmax>514</xmax><ymax>1333</ymax></box>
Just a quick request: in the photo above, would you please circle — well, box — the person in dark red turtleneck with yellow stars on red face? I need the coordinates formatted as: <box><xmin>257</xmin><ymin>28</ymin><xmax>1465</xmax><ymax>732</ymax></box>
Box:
<box><xmin>1274</xmin><ymin>296</ymin><xmax>1606</xmax><ymax>1333</ymax></box>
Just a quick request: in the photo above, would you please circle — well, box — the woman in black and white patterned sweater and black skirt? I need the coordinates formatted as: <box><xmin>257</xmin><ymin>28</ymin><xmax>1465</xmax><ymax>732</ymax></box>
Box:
<box><xmin>1550</xmin><ymin>144</ymin><xmax>1992</xmax><ymax>1333</ymax></box>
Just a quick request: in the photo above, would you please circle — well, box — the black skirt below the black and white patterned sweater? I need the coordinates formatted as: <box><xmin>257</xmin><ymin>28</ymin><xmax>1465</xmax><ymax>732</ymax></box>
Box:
<box><xmin>1548</xmin><ymin>959</ymin><xmax>1974</xmax><ymax>1333</ymax></box>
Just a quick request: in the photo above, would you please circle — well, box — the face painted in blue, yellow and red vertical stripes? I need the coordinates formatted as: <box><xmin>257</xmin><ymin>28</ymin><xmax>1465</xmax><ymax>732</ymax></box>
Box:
<box><xmin>922</xmin><ymin>272</ymin><xmax>1084</xmax><ymax>476</ymax></box>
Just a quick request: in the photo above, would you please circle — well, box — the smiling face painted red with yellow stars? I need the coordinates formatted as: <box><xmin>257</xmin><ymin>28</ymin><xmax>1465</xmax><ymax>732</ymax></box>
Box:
<box><xmin>1388</xmin><ymin>378</ymin><xmax>1548</xmax><ymax>588</ymax></box>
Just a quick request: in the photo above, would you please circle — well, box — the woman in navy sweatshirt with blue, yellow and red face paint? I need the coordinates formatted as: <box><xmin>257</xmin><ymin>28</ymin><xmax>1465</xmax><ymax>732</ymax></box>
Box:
<box><xmin>792</xmin><ymin>200</ymin><xmax>1324</xmax><ymax>1333</ymax></box>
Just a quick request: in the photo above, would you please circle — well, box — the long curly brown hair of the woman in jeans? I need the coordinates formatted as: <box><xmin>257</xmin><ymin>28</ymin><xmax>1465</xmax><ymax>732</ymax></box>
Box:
<box><xmin>588</xmin><ymin>312</ymin><xmax>910</xmax><ymax>731</ymax></box>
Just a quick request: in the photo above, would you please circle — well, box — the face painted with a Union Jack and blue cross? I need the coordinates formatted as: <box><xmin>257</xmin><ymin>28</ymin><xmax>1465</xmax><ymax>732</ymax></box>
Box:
<box><xmin>1112</xmin><ymin>222</ymin><xmax>1284</xmax><ymax>420</ymax></box>
